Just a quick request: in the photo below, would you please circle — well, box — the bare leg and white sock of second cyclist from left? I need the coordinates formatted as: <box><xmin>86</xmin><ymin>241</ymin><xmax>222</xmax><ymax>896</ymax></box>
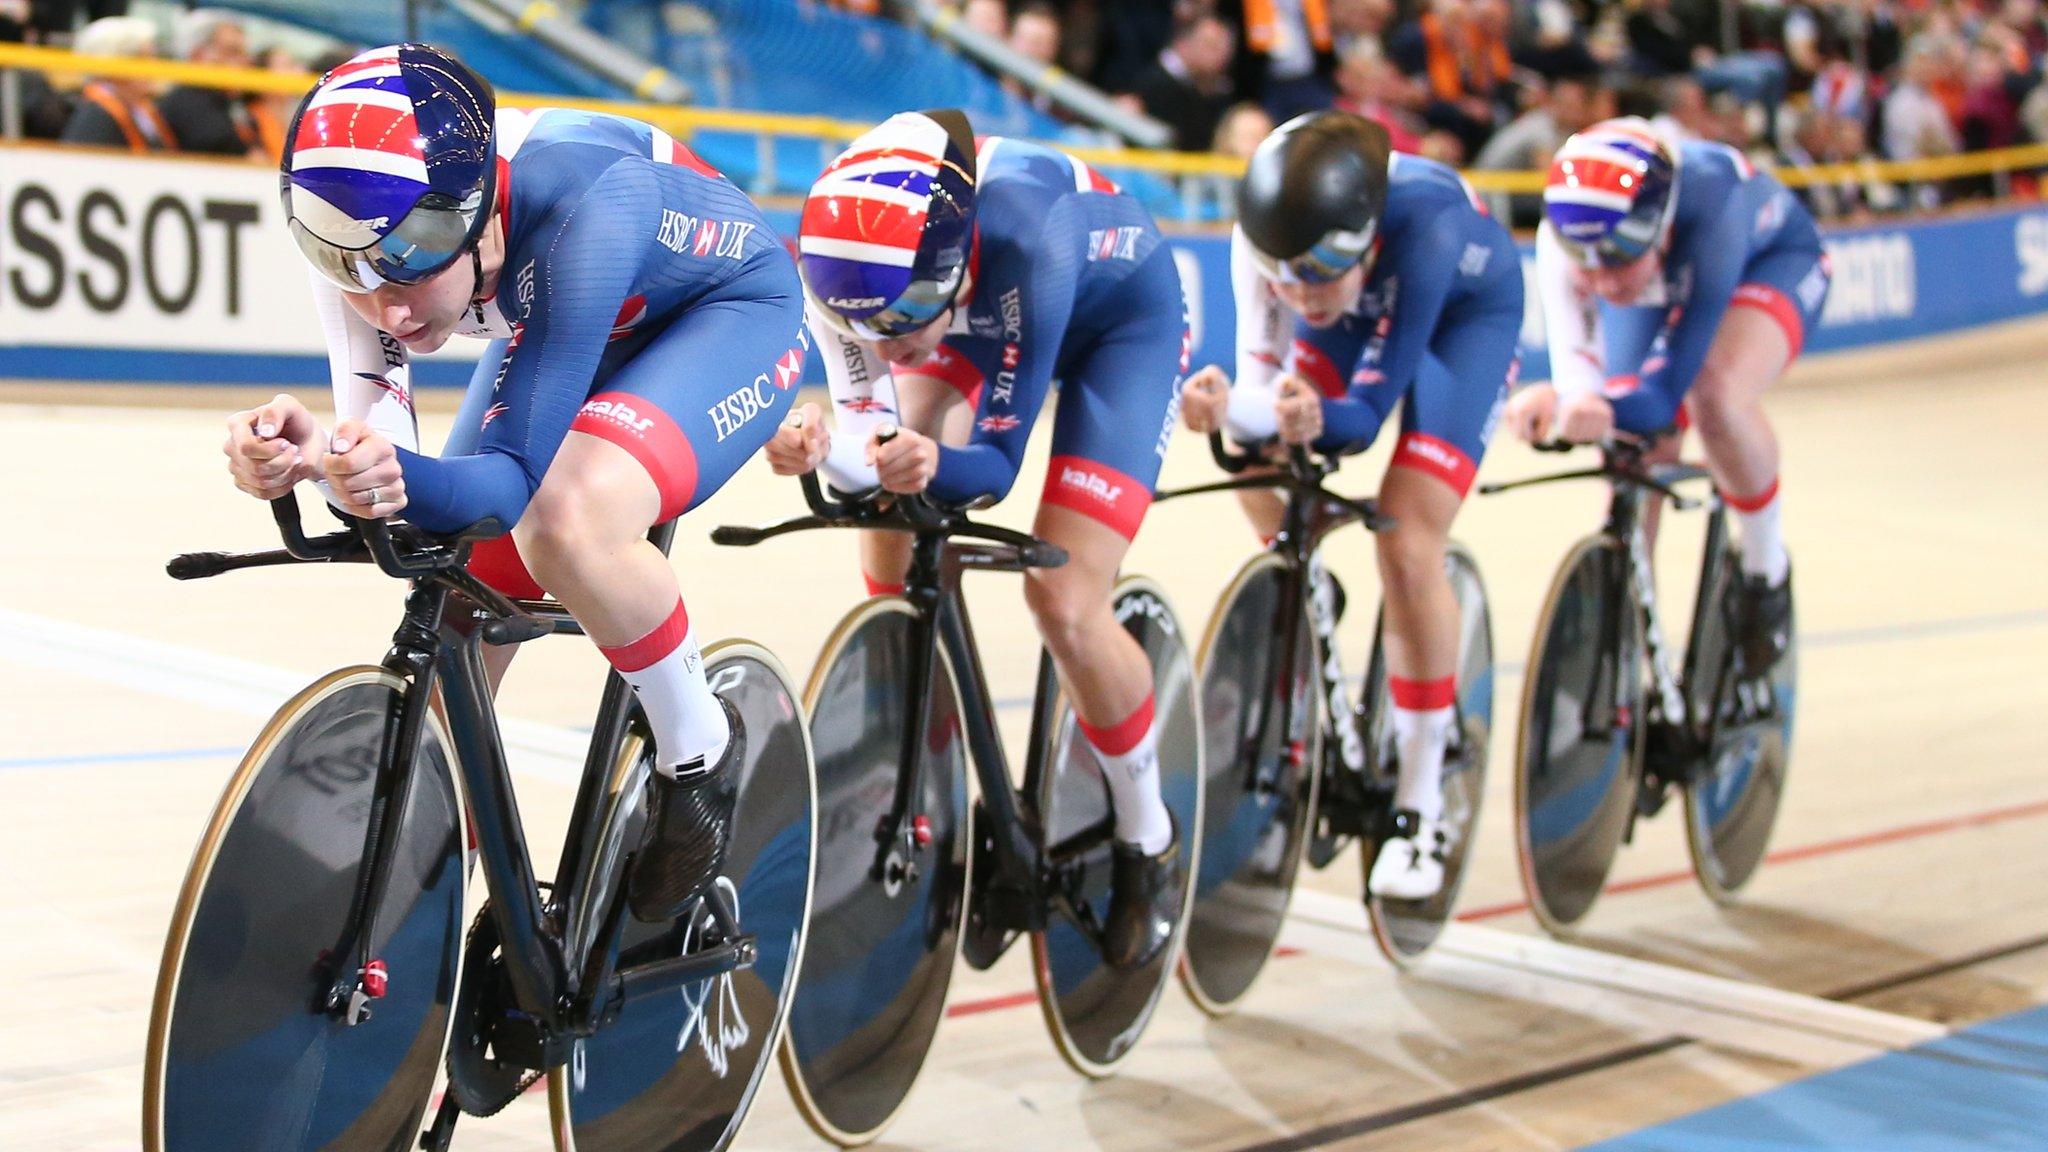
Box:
<box><xmin>1024</xmin><ymin>504</ymin><xmax>1174</xmax><ymax>853</ymax></box>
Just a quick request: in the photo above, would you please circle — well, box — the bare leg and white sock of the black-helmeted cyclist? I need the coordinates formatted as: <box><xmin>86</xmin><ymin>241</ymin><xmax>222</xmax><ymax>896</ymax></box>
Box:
<box><xmin>1374</xmin><ymin>467</ymin><xmax>1462</xmax><ymax>820</ymax></box>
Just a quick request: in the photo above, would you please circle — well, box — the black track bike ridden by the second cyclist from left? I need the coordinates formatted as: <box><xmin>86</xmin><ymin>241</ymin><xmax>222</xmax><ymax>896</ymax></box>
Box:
<box><xmin>713</xmin><ymin>476</ymin><xmax>1202</xmax><ymax>1146</ymax></box>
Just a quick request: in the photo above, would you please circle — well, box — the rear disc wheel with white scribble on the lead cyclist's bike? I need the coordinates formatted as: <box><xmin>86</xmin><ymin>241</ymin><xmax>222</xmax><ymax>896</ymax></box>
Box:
<box><xmin>547</xmin><ymin>640</ymin><xmax>817</xmax><ymax>1152</ymax></box>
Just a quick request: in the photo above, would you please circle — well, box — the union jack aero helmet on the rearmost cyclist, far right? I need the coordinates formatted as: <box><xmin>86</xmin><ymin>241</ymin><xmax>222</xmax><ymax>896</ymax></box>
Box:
<box><xmin>1542</xmin><ymin>117</ymin><xmax>1677</xmax><ymax>269</ymax></box>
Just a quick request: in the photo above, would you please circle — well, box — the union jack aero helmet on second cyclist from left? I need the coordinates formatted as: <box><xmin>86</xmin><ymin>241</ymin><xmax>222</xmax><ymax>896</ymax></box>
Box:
<box><xmin>797</xmin><ymin>109</ymin><xmax>975</xmax><ymax>340</ymax></box>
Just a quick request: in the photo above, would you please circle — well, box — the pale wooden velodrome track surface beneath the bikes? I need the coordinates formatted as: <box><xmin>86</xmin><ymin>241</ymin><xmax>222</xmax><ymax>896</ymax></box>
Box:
<box><xmin>12</xmin><ymin>313</ymin><xmax>2048</xmax><ymax>1152</ymax></box>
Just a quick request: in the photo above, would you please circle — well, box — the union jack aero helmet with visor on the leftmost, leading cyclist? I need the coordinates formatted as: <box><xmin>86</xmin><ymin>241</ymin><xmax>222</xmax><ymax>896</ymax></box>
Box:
<box><xmin>279</xmin><ymin>43</ymin><xmax>498</xmax><ymax>293</ymax></box>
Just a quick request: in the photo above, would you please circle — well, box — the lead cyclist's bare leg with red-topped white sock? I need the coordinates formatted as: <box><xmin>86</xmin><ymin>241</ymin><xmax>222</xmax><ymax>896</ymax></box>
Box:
<box><xmin>512</xmin><ymin>433</ymin><xmax>729</xmax><ymax>771</ymax></box>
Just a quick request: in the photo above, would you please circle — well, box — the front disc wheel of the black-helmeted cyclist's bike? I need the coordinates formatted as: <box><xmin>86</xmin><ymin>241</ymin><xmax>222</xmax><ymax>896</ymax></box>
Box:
<box><xmin>1180</xmin><ymin>553</ymin><xmax>1321</xmax><ymax>1017</ymax></box>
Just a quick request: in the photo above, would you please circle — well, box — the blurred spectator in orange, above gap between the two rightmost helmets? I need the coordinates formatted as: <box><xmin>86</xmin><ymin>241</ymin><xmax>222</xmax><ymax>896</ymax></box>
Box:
<box><xmin>1386</xmin><ymin>0</ymin><xmax>1513</xmax><ymax>156</ymax></box>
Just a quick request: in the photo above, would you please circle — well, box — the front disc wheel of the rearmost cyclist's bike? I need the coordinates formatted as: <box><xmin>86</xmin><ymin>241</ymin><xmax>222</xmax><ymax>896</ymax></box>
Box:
<box><xmin>1516</xmin><ymin>535</ymin><xmax>1647</xmax><ymax>935</ymax></box>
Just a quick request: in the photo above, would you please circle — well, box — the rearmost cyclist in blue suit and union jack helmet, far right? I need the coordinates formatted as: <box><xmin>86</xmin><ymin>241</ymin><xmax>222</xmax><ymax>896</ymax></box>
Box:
<box><xmin>1507</xmin><ymin>117</ymin><xmax>1829</xmax><ymax>672</ymax></box>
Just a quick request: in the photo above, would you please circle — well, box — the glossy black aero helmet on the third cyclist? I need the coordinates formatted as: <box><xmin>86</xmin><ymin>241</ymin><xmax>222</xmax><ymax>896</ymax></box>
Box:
<box><xmin>1237</xmin><ymin>111</ymin><xmax>1393</xmax><ymax>283</ymax></box>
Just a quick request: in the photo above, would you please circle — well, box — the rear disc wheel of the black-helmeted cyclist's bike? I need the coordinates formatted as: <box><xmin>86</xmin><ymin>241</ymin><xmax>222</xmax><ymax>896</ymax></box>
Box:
<box><xmin>1360</xmin><ymin>543</ymin><xmax>1493</xmax><ymax>968</ymax></box>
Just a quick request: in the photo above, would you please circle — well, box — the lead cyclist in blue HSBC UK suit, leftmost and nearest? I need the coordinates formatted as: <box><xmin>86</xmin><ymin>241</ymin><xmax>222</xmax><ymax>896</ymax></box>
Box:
<box><xmin>225</xmin><ymin>43</ymin><xmax>809</xmax><ymax>920</ymax></box>
